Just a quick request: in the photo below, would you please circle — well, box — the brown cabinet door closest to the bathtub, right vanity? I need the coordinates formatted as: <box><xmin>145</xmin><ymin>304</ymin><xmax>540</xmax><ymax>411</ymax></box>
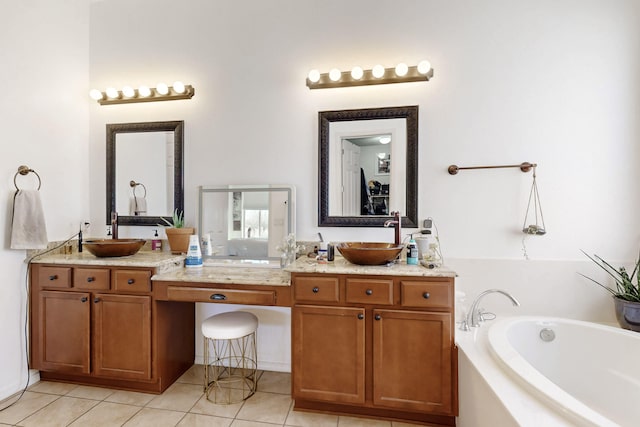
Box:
<box><xmin>373</xmin><ymin>310</ymin><xmax>453</xmax><ymax>414</ymax></box>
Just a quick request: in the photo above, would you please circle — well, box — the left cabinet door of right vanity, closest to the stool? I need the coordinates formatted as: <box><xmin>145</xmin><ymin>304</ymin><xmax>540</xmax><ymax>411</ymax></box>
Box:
<box><xmin>292</xmin><ymin>306</ymin><xmax>365</xmax><ymax>403</ymax></box>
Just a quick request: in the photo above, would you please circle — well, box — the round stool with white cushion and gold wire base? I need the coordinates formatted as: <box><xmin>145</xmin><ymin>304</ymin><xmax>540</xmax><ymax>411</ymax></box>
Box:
<box><xmin>202</xmin><ymin>311</ymin><xmax>258</xmax><ymax>405</ymax></box>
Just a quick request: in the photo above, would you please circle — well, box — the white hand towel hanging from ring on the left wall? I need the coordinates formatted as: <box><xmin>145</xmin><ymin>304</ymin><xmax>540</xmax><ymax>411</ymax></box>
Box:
<box><xmin>11</xmin><ymin>190</ymin><xmax>48</xmax><ymax>249</ymax></box>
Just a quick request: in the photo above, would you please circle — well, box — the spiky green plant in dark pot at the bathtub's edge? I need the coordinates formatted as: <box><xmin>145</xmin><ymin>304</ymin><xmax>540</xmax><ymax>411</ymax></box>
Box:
<box><xmin>580</xmin><ymin>251</ymin><xmax>640</xmax><ymax>332</ymax></box>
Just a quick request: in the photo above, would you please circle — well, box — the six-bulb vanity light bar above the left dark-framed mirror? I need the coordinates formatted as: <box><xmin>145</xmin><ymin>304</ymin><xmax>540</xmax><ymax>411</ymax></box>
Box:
<box><xmin>89</xmin><ymin>82</ymin><xmax>196</xmax><ymax>105</ymax></box>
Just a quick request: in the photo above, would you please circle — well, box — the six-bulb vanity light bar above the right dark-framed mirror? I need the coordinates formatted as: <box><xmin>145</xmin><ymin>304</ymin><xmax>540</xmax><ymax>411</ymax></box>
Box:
<box><xmin>307</xmin><ymin>61</ymin><xmax>433</xmax><ymax>89</ymax></box>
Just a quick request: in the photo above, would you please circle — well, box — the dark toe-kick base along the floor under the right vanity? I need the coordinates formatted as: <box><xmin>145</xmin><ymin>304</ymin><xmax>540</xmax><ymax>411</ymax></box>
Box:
<box><xmin>294</xmin><ymin>399</ymin><xmax>456</xmax><ymax>426</ymax></box>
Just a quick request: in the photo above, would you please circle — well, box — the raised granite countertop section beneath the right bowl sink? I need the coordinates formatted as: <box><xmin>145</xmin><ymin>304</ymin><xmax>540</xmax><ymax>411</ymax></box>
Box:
<box><xmin>284</xmin><ymin>256</ymin><xmax>456</xmax><ymax>277</ymax></box>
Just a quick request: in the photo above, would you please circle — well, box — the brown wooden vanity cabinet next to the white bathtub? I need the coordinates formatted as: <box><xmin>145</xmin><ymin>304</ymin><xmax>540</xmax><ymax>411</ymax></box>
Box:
<box><xmin>291</xmin><ymin>273</ymin><xmax>457</xmax><ymax>425</ymax></box>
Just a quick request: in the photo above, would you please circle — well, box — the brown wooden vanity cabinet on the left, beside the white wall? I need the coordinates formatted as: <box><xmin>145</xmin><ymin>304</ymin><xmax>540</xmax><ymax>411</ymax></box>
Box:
<box><xmin>31</xmin><ymin>264</ymin><xmax>193</xmax><ymax>392</ymax></box>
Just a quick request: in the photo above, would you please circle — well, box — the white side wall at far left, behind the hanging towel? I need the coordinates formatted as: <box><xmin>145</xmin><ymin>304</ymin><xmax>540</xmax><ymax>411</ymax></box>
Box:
<box><xmin>0</xmin><ymin>0</ymin><xmax>89</xmax><ymax>400</ymax></box>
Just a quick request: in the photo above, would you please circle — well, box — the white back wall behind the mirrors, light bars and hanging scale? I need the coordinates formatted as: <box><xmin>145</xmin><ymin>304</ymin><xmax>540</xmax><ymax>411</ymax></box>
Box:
<box><xmin>89</xmin><ymin>0</ymin><xmax>640</xmax><ymax>368</ymax></box>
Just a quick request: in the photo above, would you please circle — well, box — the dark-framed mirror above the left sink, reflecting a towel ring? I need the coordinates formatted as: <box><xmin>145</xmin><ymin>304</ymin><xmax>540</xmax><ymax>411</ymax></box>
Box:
<box><xmin>106</xmin><ymin>120</ymin><xmax>184</xmax><ymax>226</ymax></box>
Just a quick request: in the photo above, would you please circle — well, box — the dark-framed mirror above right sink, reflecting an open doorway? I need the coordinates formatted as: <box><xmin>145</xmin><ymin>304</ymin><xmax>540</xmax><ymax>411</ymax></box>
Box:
<box><xmin>318</xmin><ymin>106</ymin><xmax>418</xmax><ymax>227</ymax></box>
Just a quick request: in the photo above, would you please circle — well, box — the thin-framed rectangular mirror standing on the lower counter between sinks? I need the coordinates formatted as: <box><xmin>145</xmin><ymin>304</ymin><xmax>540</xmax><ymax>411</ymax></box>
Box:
<box><xmin>198</xmin><ymin>184</ymin><xmax>295</xmax><ymax>262</ymax></box>
